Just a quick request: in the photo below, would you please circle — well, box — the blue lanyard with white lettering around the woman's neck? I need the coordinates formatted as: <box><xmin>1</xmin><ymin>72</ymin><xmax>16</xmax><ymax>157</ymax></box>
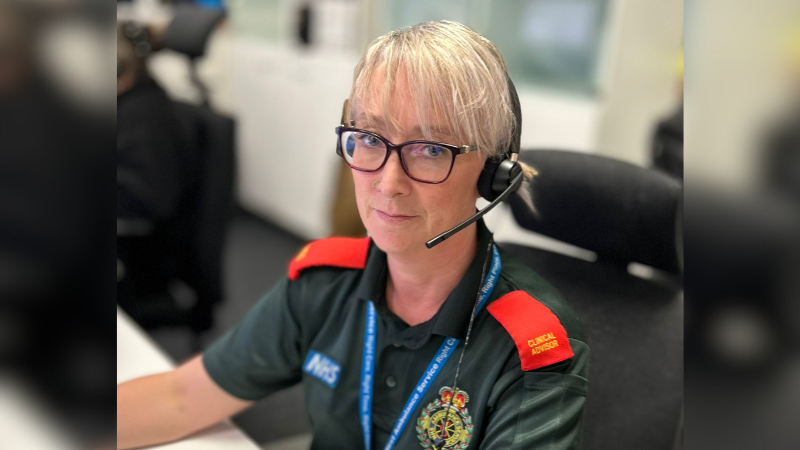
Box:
<box><xmin>359</xmin><ymin>245</ymin><xmax>501</xmax><ymax>450</ymax></box>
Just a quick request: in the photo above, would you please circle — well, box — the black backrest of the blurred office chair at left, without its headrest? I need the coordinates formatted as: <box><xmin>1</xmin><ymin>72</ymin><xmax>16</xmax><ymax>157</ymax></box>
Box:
<box><xmin>168</xmin><ymin>102</ymin><xmax>235</xmax><ymax>331</ymax></box>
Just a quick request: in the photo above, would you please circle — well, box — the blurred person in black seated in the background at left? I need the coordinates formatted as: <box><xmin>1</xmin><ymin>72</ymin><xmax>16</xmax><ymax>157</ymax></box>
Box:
<box><xmin>116</xmin><ymin>17</ymin><xmax>197</xmax><ymax>325</ymax></box>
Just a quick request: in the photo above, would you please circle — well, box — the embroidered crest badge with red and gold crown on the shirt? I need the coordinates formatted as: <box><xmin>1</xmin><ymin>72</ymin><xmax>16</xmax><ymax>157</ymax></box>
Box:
<box><xmin>417</xmin><ymin>386</ymin><xmax>474</xmax><ymax>450</ymax></box>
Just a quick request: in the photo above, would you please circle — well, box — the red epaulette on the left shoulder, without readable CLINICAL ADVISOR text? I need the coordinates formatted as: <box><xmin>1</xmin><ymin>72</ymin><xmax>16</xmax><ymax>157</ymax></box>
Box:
<box><xmin>289</xmin><ymin>237</ymin><xmax>369</xmax><ymax>280</ymax></box>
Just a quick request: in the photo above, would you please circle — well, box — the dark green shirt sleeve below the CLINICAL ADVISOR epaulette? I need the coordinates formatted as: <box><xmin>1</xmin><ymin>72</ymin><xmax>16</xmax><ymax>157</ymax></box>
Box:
<box><xmin>480</xmin><ymin>339</ymin><xmax>589</xmax><ymax>450</ymax></box>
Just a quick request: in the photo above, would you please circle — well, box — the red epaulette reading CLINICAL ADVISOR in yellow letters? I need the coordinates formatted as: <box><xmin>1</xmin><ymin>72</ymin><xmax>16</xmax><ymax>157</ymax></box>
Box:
<box><xmin>487</xmin><ymin>291</ymin><xmax>573</xmax><ymax>371</ymax></box>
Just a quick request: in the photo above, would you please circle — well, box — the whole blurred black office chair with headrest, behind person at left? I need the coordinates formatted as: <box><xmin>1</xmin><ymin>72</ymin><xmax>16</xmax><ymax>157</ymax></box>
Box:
<box><xmin>118</xmin><ymin>7</ymin><xmax>235</xmax><ymax>340</ymax></box>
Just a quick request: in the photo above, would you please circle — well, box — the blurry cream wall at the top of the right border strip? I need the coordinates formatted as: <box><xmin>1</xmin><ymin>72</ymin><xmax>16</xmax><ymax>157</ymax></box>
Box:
<box><xmin>685</xmin><ymin>0</ymin><xmax>800</xmax><ymax>189</ymax></box>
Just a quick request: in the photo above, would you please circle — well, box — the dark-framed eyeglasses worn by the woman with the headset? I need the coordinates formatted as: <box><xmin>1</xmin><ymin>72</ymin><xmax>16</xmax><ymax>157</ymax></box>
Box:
<box><xmin>336</xmin><ymin>126</ymin><xmax>478</xmax><ymax>184</ymax></box>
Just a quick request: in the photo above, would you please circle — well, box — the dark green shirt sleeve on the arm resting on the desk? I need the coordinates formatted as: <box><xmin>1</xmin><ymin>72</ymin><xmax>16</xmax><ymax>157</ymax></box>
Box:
<box><xmin>203</xmin><ymin>278</ymin><xmax>302</xmax><ymax>400</ymax></box>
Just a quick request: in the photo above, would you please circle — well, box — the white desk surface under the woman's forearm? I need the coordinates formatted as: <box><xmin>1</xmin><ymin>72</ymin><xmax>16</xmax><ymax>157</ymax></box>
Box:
<box><xmin>117</xmin><ymin>308</ymin><xmax>260</xmax><ymax>450</ymax></box>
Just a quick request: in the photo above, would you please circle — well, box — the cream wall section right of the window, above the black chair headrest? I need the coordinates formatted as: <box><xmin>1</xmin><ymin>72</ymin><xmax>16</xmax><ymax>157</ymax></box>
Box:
<box><xmin>596</xmin><ymin>0</ymin><xmax>683</xmax><ymax>165</ymax></box>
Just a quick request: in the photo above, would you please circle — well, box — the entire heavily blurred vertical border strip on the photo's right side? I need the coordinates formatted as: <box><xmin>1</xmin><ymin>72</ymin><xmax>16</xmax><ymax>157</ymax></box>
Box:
<box><xmin>684</xmin><ymin>0</ymin><xmax>800</xmax><ymax>449</ymax></box>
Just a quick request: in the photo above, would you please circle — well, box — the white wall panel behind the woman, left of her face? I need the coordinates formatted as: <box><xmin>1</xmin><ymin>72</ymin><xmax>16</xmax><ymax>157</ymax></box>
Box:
<box><xmin>232</xmin><ymin>40</ymin><xmax>358</xmax><ymax>239</ymax></box>
